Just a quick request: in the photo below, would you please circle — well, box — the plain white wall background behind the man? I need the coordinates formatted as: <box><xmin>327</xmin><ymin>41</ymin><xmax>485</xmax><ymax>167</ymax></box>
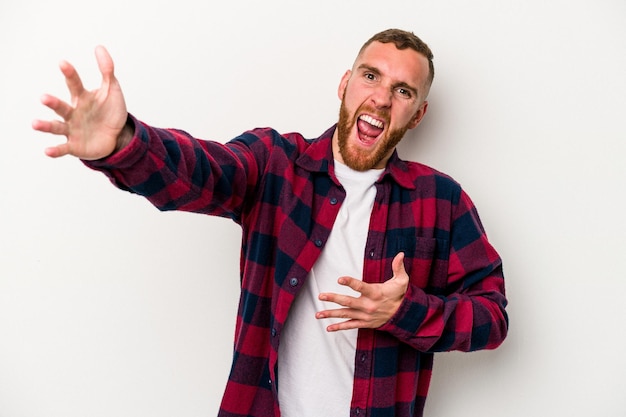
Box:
<box><xmin>0</xmin><ymin>0</ymin><xmax>626</xmax><ymax>417</ymax></box>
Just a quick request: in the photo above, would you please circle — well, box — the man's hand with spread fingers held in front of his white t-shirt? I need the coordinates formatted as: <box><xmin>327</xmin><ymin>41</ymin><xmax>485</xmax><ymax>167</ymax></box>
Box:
<box><xmin>315</xmin><ymin>252</ymin><xmax>409</xmax><ymax>332</ymax></box>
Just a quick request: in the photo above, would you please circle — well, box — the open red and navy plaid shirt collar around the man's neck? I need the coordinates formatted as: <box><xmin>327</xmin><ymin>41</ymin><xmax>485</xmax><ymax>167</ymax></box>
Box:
<box><xmin>296</xmin><ymin>124</ymin><xmax>415</xmax><ymax>189</ymax></box>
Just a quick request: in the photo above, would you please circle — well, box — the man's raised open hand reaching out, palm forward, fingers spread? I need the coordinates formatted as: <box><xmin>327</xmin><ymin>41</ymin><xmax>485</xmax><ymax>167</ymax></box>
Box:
<box><xmin>32</xmin><ymin>46</ymin><xmax>132</xmax><ymax>160</ymax></box>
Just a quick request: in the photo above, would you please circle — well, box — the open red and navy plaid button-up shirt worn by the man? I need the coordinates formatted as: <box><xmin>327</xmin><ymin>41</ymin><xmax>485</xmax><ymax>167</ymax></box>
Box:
<box><xmin>87</xmin><ymin>117</ymin><xmax>508</xmax><ymax>417</ymax></box>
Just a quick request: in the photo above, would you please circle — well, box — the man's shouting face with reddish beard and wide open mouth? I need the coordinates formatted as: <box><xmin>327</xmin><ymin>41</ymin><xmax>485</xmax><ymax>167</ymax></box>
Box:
<box><xmin>333</xmin><ymin>42</ymin><xmax>428</xmax><ymax>171</ymax></box>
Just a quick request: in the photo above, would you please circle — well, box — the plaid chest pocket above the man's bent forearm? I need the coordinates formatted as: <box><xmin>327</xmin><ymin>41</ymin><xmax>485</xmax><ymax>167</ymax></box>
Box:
<box><xmin>395</xmin><ymin>235</ymin><xmax>449</xmax><ymax>293</ymax></box>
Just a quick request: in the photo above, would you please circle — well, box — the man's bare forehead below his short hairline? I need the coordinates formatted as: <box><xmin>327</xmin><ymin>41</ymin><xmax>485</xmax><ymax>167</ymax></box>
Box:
<box><xmin>352</xmin><ymin>42</ymin><xmax>428</xmax><ymax>87</ymax></box>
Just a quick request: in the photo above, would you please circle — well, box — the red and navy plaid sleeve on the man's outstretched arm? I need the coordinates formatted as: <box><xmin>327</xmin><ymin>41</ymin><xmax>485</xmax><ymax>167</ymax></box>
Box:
<box><xmin>84</xmin><ymin>116</ymin><xmax>263</xmax><ymax>221</ymax></box>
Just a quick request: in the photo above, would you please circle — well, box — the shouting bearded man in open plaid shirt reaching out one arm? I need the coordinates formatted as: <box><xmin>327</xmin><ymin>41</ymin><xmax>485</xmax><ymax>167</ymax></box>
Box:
<box><xmin>33</xmin><ymin>29</ymin><xmax>508</xmax><ymax>417</ymax></box>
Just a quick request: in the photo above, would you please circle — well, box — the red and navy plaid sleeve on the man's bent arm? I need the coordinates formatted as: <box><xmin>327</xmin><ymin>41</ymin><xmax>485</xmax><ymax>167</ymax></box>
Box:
<box><xmin>379</xmin><ymin>188</ymin><xmax>509</xmax><ymax>352</ymax></box>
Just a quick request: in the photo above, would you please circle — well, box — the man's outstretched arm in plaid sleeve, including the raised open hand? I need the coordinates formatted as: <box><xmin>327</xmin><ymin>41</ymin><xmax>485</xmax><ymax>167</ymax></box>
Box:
<box><xmin>32</xmin><ymin>46</ymin><xmax>258</xmax><ymax>217</ymax></box>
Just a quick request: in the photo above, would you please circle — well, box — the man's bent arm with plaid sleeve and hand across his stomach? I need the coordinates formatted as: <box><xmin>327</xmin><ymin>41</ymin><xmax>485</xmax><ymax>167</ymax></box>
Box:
<box><xmin>317</xmin><ymin>194</ymin><xmax>508</xmax><ymax>352</ymax></box>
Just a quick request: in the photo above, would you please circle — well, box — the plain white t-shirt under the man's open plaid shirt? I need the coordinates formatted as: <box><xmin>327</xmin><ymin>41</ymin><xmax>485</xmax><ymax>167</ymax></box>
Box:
<box><xmin>278</xmin><ymin>161</ymin><xmax>383</xmax><ymax>417</ymax></box>
